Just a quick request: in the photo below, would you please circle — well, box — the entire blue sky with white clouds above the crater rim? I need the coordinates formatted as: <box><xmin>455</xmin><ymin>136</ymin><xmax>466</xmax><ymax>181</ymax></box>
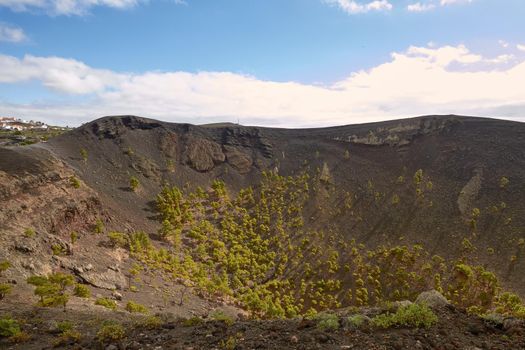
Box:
<box><xmin>0</xmin><ymin>0</ymin><xmax>525</xmax><ymax>127</ymax></box>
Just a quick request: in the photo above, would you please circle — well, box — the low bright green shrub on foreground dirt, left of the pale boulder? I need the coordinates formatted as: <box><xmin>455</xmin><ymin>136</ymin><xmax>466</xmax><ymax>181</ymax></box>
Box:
<box><xmin>372</xmin><ymin>304</ymin><xmax>438</xmax><ymax>328</ymax></box>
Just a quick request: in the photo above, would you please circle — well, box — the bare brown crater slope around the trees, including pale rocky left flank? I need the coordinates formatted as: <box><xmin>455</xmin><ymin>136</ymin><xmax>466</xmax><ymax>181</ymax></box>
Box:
<box><xmin>0</xmin><ymin>116</ymin><xmax>525</xmax><ymax>320</ymax></box>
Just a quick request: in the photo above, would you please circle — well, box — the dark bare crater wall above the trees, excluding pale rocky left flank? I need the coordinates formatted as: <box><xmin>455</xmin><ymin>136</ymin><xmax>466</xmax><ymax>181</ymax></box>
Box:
<box><xmin>44</xmin><ymin>116</ymin><xmax>525</xmax><ymax>288</ymax></box>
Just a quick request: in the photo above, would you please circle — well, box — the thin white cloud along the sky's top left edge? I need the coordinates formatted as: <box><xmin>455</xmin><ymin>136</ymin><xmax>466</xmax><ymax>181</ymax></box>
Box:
<box><xmin>0</xmin><ymin>0</ymin><xmax>143</xmax><ymax>15</ymax></box>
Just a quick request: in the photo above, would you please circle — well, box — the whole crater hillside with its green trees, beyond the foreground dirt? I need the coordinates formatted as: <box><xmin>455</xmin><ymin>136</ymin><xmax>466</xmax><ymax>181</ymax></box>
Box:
<box><xmin>0</xmin><ymin>116</ymin><xmax>525</xmax><ymax>348</ymax></box>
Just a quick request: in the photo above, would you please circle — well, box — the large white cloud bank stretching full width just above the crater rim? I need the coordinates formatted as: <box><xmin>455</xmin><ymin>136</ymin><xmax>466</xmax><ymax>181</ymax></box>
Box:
<box><xmin>0</xmin><ymin>45</ymin><xmax>525</xmax><ymax>127</ymax></box>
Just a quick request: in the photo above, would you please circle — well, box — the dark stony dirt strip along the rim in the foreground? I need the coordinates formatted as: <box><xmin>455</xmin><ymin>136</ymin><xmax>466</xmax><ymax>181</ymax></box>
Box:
<box><xmin>0</xmin><ymin>306</ymin><xmax>525</xmax><ymax>350</ymax></box>
